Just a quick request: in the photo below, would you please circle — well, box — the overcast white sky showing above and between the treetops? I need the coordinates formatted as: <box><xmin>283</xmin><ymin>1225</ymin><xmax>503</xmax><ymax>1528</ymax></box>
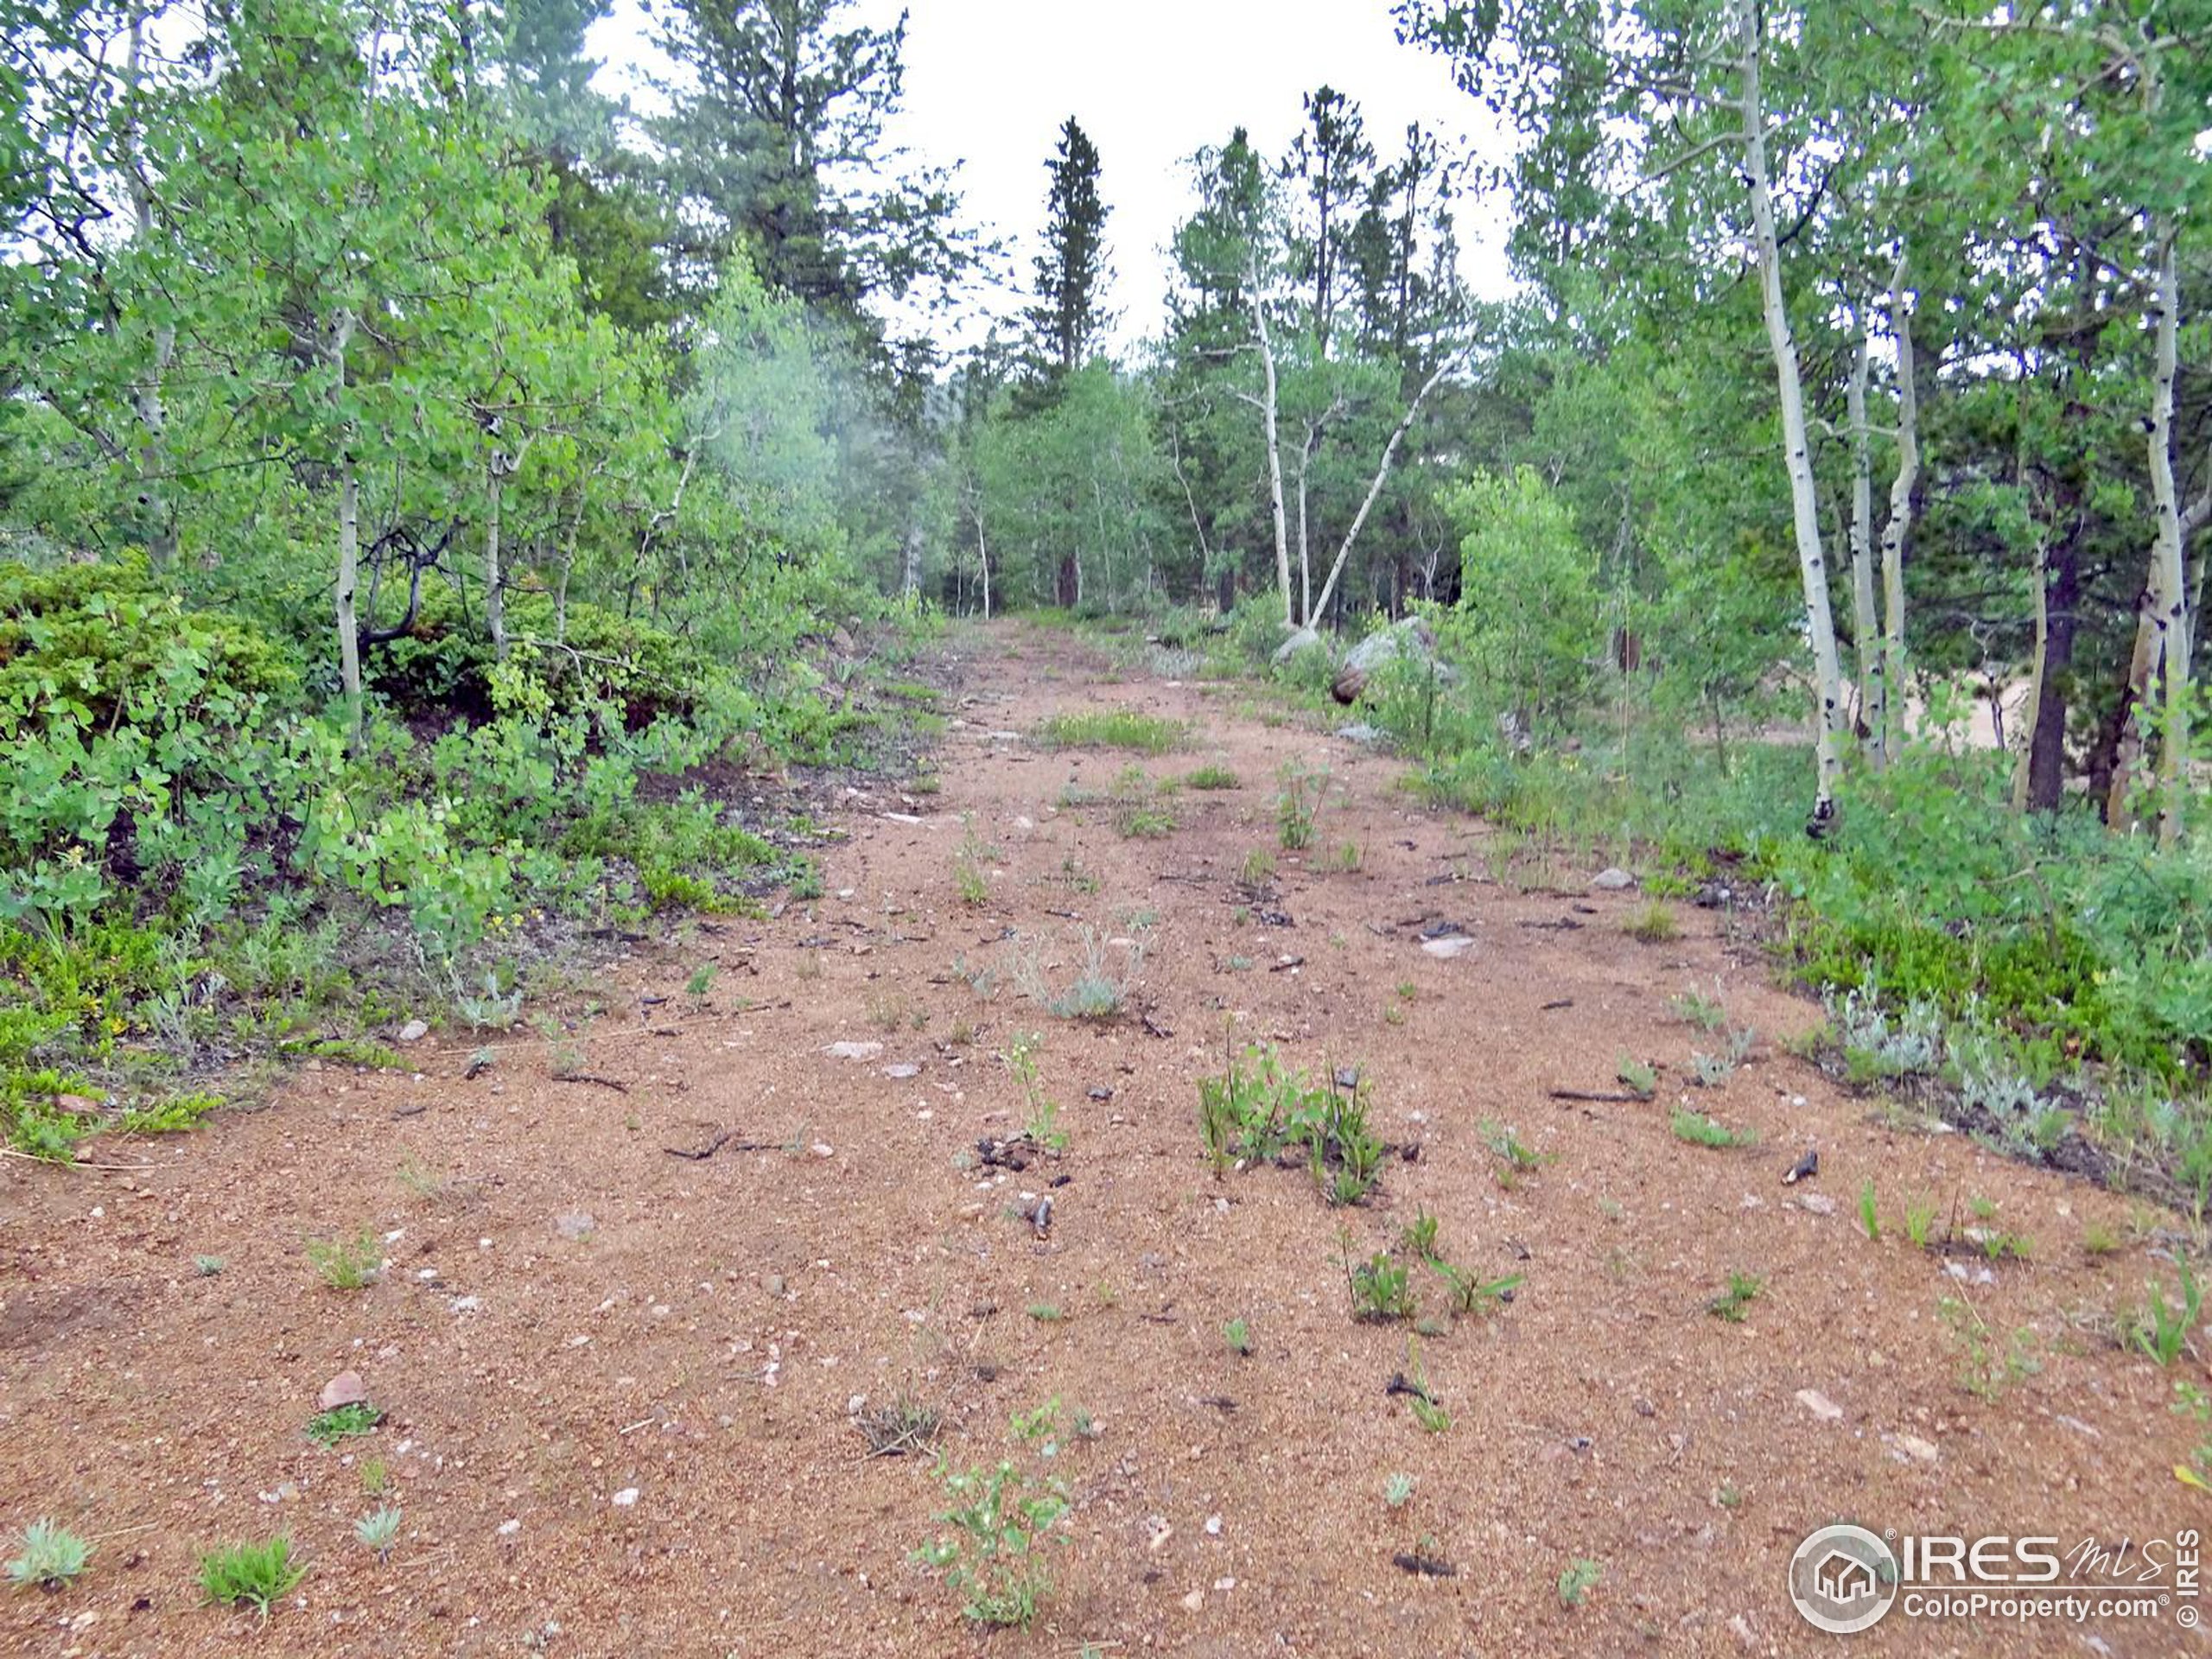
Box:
<box><xmin>591</xmin><ymin>0</ymin><xmax>1506</xmax><ymax>345</ymax></box>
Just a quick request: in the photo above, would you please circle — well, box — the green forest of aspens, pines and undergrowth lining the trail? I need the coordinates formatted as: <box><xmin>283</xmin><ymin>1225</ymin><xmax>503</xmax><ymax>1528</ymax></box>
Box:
<box><xmin>0</xmin><ymin>0</ymin><xmax>2212</xmax><ymax>1201</ymax></box>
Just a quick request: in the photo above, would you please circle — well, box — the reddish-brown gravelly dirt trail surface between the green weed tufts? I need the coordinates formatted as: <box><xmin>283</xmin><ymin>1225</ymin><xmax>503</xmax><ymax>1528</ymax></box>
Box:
<box><xmin>0</xmin><ymin>626</ymin><xmax>2205</xmax><ymax>1659</ymax></box>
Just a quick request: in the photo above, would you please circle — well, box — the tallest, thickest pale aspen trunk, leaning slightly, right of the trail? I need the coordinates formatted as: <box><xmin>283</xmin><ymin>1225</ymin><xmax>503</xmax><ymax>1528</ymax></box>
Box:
<box><xmin>1737</xmin><ymin>0</ymin><xmax>1842</xmax><ymax>827</ymax></box>
